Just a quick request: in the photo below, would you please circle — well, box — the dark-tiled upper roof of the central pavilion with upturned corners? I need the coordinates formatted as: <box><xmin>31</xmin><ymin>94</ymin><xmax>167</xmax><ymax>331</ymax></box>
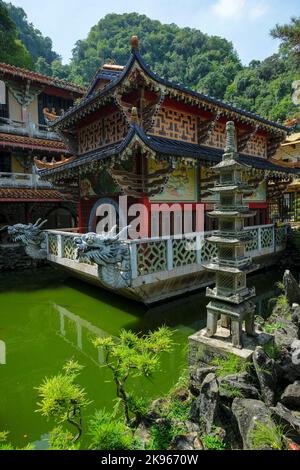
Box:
<box><xmin>53</xmin><ymin>43</ymin><xmax>293</xmax><ymax>133</ymax></box>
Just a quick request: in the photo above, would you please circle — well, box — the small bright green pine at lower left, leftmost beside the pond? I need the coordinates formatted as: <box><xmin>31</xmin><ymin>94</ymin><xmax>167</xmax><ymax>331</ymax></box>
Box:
<box><xmin>37</xmin><ymin>360</ymin><xmax>91</xmax><ymax>444</ymax></box>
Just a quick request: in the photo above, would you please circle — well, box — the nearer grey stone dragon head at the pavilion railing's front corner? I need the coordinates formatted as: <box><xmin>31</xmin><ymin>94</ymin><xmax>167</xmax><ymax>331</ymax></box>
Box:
<box><xmin>75</xmin><ymin>227</ymin><xmax>131</xmax><ymax>289</ymax></box>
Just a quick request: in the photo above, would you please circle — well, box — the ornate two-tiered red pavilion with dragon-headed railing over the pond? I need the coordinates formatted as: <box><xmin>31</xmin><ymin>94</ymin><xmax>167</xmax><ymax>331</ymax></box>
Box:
<box><xmin>20</xmin><ymin>36</ymin><xmax>299</xmax><ymax>303</ymax></box>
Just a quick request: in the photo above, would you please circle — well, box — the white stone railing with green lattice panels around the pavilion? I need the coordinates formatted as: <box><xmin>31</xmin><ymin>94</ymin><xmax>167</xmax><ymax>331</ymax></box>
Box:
<box><xmin>46</xmin><ymin>225</ymin><xmax>287</xmax><ymax>279</ymax></box>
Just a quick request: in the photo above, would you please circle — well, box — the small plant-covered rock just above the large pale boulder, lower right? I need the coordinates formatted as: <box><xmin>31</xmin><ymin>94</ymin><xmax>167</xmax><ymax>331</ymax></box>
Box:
<box><xmin>219</xmin><ymin>372</ymin><xmax>259</xmax><ymax>399</ymax></box>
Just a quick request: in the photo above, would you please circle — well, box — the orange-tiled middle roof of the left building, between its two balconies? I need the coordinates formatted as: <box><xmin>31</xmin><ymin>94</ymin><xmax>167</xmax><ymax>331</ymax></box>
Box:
<box><xmin>0</xmin><ymin>133</ymin><xmax>69</xmax><ymax>153</ymax></box>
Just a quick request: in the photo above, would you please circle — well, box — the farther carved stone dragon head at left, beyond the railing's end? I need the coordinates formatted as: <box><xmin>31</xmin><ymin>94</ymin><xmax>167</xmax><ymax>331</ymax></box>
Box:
<box><xmin>7</xmin><ymin>219</ymin><xmax>47</xmax><ymax>259</ymax></box>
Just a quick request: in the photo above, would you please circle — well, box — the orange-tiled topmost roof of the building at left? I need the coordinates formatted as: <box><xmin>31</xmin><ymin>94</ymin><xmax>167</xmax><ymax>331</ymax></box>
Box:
<box><xmin>0</xmin><ymin>63</ymin><xmax>86</xmax><ymax>95</ymax></box>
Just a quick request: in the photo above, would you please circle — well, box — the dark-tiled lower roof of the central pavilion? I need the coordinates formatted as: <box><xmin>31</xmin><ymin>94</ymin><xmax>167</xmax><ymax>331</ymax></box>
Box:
<box><xmin>38</xmin><ymin>124</ymin><xmax>300</xmax><ymax>177</ymax></box>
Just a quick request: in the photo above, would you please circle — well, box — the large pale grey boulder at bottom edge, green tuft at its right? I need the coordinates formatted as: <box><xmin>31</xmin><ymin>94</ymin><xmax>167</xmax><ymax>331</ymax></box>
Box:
<box><xmin>232</xmin><ymin>398</ymin><xmax>275</xmax><ymax>450</ymax></box>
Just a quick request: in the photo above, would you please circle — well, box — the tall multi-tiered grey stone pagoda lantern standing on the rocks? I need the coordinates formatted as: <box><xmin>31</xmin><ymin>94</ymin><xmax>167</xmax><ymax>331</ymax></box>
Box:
<box><xmin>204</xmin><ymin>122</ymin><xmax>257</xmax><ymax>349</ymax></box>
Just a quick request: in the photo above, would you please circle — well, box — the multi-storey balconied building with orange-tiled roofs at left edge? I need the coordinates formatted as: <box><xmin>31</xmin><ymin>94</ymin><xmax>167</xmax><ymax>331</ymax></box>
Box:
<box><xmin>0</xmin><ymin>63</ymin><xmax>85</xmax><ymax>241</ymax></box>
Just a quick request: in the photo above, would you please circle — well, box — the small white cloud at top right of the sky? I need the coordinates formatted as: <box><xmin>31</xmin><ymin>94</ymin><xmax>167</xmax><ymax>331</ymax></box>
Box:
<box><xmin>212</xmin><ymin>0</ymin><xmax>268</xmax><ymax>20</ymax></box>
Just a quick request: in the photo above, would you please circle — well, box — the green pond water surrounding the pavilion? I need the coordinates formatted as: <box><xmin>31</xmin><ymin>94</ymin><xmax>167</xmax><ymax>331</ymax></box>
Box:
<box><xmin>0</xmin><ymin>268</ymin><xmax>282</xmax><ymax>448</ymax></box>
